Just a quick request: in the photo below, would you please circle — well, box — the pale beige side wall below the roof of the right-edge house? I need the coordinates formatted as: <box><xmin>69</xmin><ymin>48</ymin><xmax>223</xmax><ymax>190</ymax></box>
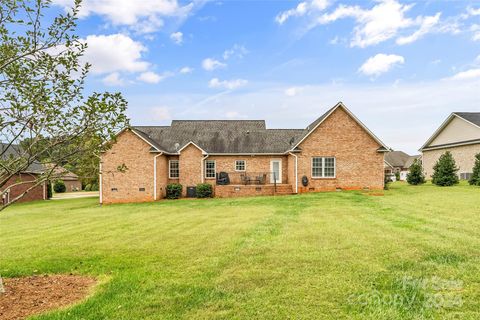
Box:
<box><xmin>422</xmin><ymin>144</ymin><xmax>480</xmax><ymax>179</ymax></box>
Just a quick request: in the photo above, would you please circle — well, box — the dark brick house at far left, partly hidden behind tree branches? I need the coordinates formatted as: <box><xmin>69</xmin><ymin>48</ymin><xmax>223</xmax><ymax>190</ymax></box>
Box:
<box><xmin>0</xmin><ymin>143</ymin><xmax>47</xmax><ymax>204</ymax></box>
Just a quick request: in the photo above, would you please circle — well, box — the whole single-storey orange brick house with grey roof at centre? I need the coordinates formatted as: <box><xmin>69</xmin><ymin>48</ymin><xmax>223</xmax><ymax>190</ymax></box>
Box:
<box><xmin>100</xmin><ymin>102</ymin><xmax>388</xmax><ymax>203</ymax></box>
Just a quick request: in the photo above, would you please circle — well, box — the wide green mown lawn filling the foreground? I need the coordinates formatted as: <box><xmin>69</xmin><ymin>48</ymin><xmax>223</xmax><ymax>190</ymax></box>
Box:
<box><xmin>0</xmin><ymin>184</ymin><xmax>480</xmax><ymax>319</ymax></box>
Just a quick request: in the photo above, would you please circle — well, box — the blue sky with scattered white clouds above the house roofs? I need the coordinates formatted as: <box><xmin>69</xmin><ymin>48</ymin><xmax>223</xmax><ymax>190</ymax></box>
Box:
<box><xmin>49</xmin><ymin>0</ymin><xmax>480</xmax><ymax>153</ymax></box>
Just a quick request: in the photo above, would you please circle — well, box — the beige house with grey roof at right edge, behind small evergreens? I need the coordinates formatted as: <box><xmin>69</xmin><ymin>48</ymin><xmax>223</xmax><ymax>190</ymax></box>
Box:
<box><xmin>420</xmin><ymin>112</ymin><xmax>480</xmax><ymax>179</ymax></box>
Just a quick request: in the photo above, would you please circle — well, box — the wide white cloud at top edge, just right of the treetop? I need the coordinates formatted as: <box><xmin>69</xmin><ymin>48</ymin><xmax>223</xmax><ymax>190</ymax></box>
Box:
<box><xmin>53</xmin><ymin>0</ymin><xmax>196</xmax><ymax>33</ymax></box>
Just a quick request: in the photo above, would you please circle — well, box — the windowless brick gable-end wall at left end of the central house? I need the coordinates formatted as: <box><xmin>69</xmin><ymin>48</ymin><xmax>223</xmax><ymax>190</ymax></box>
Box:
<box><xmin>101</xmin><ymin>130</ymin><xmax>165</xmax><ymax>203</ymax></box>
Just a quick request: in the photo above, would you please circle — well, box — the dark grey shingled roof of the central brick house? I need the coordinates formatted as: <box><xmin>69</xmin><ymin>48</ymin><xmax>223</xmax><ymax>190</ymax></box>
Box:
<box><xmin>131</xmin><ymin>103</ymin><xmax>388</xmax><ymax>154</ymax></box>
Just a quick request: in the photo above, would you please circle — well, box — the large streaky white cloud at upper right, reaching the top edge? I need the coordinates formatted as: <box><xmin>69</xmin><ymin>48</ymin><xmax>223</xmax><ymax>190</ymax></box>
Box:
<box><xmin>317</xmin><ymin>0</ymin><xmax>440</xmax><ymax>48</ymax></box>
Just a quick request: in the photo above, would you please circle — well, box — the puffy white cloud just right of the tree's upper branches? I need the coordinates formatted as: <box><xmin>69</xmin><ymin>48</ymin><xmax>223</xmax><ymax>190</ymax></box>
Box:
<box><xmin>81</xmin><ymin>34</ymin><xmax>150</xmax><ymax>74</ymax></box>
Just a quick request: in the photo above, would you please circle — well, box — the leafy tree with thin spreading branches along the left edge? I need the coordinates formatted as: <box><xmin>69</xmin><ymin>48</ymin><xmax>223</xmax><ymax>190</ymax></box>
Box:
<box><xmin>0</xmin><ymin>0</ymin><xmax>128</xmax><ymax>210</ymax></box>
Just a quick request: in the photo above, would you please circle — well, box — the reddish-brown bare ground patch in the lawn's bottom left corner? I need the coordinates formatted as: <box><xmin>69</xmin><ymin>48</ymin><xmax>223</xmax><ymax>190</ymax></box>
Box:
<box><xmin>0</xmin><ymin>275</ymin><xmax>97</xmax><ymax>320</ymax></box>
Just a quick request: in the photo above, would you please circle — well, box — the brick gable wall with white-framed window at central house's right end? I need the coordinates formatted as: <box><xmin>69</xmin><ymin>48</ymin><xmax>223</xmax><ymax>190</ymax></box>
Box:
<box><xmin>298</xmin><ymin>108</ymin><xmax>384</xmax><ymax>192</ymax></box>
